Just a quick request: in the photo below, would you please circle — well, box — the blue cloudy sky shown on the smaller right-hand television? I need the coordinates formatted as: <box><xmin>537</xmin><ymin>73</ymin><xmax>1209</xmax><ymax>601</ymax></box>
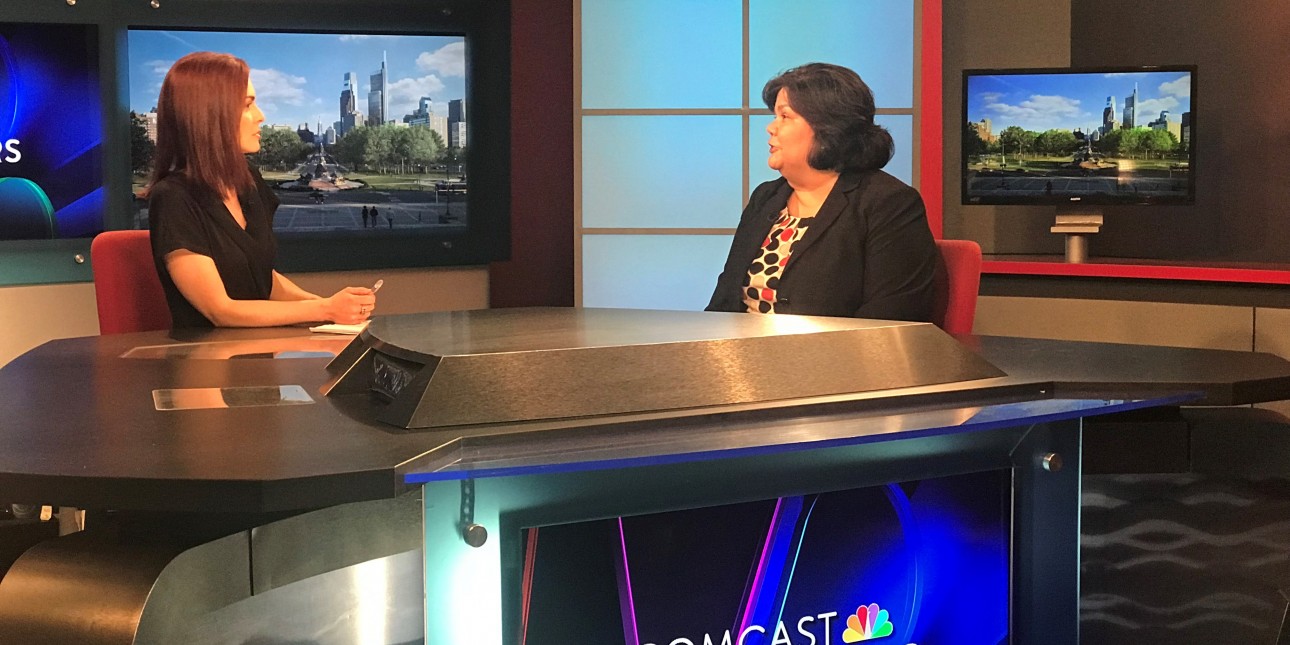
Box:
<box><xmin>968</xmin><ymin>71</ymin><xmax>1192</xmax><ymax>134</ymax></box>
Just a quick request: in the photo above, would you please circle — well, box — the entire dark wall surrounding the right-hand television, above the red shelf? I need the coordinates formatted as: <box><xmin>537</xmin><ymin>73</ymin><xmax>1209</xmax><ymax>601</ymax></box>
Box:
<box><xmin>944</xmin><ymin>0</ymin><xmax>1290</xmax><ymax>263</ymax></box>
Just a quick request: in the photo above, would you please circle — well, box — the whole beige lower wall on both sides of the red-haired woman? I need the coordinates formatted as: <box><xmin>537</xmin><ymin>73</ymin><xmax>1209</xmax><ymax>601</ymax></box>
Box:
<box><xmin>0</xmin><ymin>267</ymin><xmax>489</xmax><ymax>365</ymax></box>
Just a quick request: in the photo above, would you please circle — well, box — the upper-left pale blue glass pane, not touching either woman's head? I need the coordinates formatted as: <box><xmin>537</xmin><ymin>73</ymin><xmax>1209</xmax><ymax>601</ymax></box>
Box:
<box><xmin>582</xmin><ymin>0</ymin><xmax>743</xmax><ymax>108</ymax></box>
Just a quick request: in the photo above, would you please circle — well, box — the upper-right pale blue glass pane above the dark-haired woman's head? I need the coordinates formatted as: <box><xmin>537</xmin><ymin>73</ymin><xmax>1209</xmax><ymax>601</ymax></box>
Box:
<box><xmin>748</xmin><ymin>0</ymin><xmax>915</xmax><ymax>107</ymax></box>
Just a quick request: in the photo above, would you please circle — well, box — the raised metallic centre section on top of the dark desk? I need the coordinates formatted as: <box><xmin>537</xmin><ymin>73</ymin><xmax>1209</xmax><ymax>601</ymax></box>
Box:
<box><xmin>325</xmin><ymin>308</ymin><xmax>1005</xmax><ymax>428</ymax></box>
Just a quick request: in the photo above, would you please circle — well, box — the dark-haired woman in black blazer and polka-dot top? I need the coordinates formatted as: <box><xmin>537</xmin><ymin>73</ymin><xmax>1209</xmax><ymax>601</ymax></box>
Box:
<box><xmin>707</xmin><ymin>63</ymin><xmax>938</xmax><ymax>321</ymax></box>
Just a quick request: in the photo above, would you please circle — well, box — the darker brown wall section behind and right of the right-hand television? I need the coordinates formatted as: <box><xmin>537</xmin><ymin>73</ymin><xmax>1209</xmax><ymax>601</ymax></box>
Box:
<box><xmin>1071</xmin><ymin>0</ymin><xmax>1290</xmax><ymax>262</ymax></box>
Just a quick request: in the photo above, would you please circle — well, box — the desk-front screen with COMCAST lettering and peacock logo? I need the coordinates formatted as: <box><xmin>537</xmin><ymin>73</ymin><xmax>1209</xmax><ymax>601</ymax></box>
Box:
<box><xmin>524</xmin><ymin>471</ymin><xmax>1011</xmax><ymax>645</ymax></box>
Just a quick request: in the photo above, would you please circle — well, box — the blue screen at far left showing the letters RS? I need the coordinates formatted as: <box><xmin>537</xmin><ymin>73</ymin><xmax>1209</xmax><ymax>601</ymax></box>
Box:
<box><xmin>0</xmin><ymin>22</ymin><xmax>104</xmax><ymax>240</ymax></box>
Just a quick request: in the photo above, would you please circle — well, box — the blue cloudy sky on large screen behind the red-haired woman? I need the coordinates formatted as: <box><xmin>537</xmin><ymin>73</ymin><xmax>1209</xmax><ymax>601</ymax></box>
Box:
<box><xmin>129</xmin><ymin>30</ymin><xmax>466</xmax><ymax>130</ymax></box>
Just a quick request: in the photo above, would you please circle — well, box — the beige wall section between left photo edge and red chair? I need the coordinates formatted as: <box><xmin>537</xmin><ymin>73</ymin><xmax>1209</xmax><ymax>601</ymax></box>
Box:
<box><xmin>0</xmin><ymin>283</ymin><xmax>98</xmax><ymax>365</ymax></box>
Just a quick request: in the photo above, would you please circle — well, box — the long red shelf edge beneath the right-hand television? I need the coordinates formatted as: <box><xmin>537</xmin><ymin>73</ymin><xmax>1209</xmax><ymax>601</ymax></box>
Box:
<box><xmin>982</xmin><ymin>255</ymin><xmax>1290</xmax><ymax>285</ymax></box>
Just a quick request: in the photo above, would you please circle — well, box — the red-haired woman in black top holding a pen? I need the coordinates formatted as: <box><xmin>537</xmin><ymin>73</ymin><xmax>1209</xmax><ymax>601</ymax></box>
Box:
<box><xmin>147</xmin><ymin>52</ymin><xmax>377</xmax><ymax>328</ymax></box>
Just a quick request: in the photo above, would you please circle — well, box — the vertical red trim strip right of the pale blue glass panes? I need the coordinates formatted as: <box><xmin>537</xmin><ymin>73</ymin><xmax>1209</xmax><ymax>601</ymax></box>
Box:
<box><xmin>918</xmin><ymin>0</ymin><xmax>946</xmax><ymax>239</ymax></box>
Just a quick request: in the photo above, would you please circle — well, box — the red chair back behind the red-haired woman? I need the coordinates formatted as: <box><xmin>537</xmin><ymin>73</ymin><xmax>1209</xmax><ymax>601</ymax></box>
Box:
<box><xmin>89</xmin><ymin>231</ymin><xmax>170</xmax><ymax>334</ymax></box>
